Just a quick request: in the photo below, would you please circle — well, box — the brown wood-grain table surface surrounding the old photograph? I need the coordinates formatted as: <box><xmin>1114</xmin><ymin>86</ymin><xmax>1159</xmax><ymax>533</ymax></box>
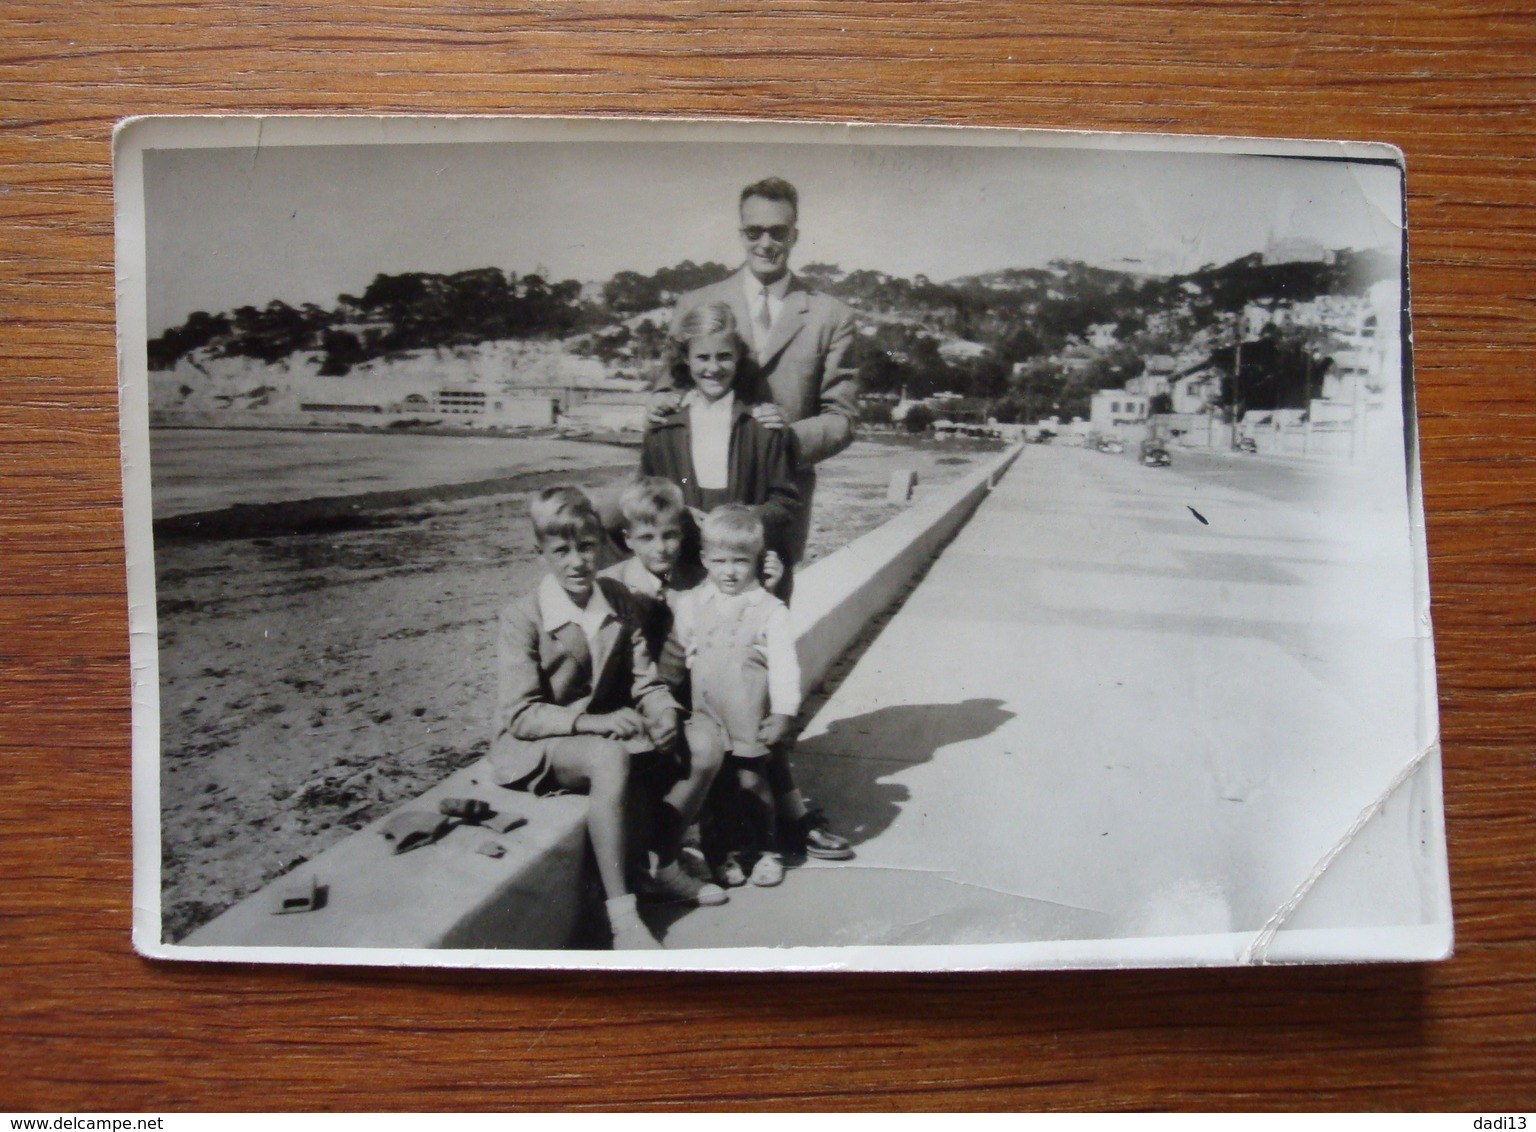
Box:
<box><xmin>0</xmin><ymin>0</ymin><xmax>1536</xmax><ymax>1112</ymax></box>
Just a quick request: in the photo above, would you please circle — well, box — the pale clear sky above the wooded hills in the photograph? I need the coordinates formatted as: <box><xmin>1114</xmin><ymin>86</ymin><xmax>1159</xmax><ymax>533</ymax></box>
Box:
<box><xmin>144</xmin><ymin>134</ymin><xmax>1401</xmax><ymax>335</ymax></box>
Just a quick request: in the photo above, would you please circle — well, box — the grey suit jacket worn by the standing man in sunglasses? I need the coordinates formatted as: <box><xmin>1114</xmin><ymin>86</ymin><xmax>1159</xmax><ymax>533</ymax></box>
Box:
<box><xmin>668</xmin><ymin>267</ymin><xmax>859</xmax><ymax>466</ymax></box>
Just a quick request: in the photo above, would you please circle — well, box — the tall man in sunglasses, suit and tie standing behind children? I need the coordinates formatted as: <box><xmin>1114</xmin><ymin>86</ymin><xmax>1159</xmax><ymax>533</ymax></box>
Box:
<box><xmin>651</xmin><ymin>177</ymin><xmax>859</xmax><ymax>860</ymax></box>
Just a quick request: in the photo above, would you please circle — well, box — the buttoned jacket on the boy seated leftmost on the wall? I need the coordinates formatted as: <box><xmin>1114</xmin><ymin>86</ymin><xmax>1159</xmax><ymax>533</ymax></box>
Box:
<box><xmin>492</xmin><ymin>578</ymin><xmax>676</xmax><ymax>788</ymax></box>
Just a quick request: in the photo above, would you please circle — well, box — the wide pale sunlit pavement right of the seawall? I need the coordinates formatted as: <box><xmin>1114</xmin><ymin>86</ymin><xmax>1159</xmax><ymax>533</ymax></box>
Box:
<box><xmin>667</xmin><ymin>447</ymin><xmax>1438</xmax><ymax>948</ymax></box>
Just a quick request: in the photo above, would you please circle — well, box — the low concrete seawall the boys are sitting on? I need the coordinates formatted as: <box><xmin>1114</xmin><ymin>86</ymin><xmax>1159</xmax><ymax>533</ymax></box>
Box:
<box><xmin>176</xmin><ymin>447</ymin><xmax>1021</xmax><ymax>962</ymax></box>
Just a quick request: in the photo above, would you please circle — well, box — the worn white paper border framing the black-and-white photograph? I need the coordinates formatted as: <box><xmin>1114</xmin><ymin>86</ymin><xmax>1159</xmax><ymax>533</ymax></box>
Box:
<box><xmin>114</xmin><ymin>115</ymin><xmax>1452</xmax><ymax>971</ymax></box>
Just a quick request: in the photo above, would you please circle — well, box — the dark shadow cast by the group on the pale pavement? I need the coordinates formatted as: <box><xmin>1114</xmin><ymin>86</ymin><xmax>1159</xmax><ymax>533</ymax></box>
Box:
<box><xmin>794</xmin><ymin>699</ymin><xmax>1015</xmax><ymax>845</ymax></box>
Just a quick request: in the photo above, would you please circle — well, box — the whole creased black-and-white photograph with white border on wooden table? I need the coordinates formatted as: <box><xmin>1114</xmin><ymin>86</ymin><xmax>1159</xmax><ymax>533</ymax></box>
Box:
<box><xmin>114</xmin><ymin>117</ymin><xmax>1452</xmax><ymax>971</ymax></box>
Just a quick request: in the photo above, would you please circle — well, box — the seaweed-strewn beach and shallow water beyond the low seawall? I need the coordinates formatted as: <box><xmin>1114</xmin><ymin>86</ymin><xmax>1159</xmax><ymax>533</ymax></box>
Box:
<box><xmin>154</xmin><ymin>430</ymin><xmax>991</xmax><ymax>940</ymax></box>
